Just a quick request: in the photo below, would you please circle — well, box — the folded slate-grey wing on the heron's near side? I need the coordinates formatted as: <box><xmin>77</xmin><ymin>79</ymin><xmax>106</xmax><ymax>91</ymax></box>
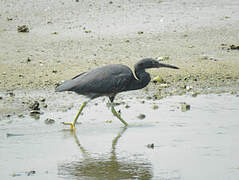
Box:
<box><xmin>70</xmin><ymin>65</ymin><xmax>133</xmax><ymax>96</ymax></box>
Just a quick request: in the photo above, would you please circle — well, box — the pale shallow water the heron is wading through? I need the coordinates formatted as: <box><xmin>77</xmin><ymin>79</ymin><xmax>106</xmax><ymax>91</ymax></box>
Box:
<box><xmin>0</xmin><ymin>93</ymin><xmax>239</xmax><ymax>180</ymax></box>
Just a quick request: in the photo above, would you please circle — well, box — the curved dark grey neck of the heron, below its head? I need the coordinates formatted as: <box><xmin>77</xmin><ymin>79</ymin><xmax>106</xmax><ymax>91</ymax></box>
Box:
<box><xmin>130</xmin><ymin>69</ymin><xmax>151</xmax><ymax>90</ymax></box>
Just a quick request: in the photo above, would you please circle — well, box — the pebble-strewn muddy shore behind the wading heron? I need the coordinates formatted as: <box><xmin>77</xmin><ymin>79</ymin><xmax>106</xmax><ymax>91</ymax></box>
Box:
<box><xmin>0</xmin><ymin>0</ymin><xmax>239</xmax><ymax>105</ymax></box>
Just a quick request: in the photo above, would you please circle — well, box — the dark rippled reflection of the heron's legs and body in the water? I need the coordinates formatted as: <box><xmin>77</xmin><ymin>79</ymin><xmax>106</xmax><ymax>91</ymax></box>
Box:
<box><xmin>58</xmin><ymin>127</ymin><xmax>153</xmax><ymax>180</ymax></box>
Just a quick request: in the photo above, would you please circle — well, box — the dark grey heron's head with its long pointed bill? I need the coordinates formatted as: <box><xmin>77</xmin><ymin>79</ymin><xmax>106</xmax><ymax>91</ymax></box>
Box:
<box><xmin>134</xmin><ymin>58</ymin><xmax>179</xmax><ymax>70</ymax></box>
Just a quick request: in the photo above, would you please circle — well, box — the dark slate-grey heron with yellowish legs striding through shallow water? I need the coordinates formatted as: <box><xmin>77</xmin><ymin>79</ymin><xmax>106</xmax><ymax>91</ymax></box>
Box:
<box><xmin>56</xmin><ymin>58</ymin><xmax>179</xmax><ymax>130</ymax></box>
